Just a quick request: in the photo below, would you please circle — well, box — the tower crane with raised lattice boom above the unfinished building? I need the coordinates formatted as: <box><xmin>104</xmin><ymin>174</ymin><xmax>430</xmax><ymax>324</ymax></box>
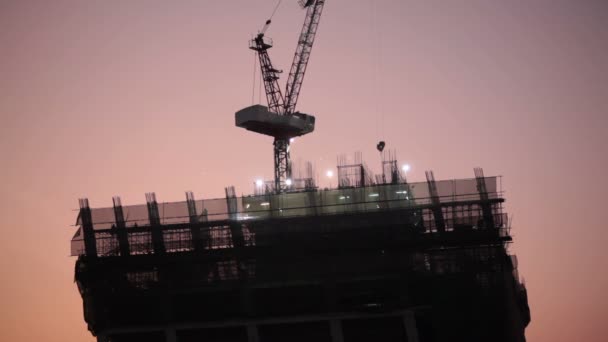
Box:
<box><xmin>235</xmin><ymin>0</ymin><xmax>325</xmax><ymax>193</ymax></box>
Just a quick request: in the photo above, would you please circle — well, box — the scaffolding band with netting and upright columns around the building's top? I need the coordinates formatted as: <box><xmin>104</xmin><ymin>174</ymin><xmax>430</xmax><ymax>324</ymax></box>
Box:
<box><xmin>71</xmin><ymin>177</ymin><xmax>508</xmax><ymax>257</ymax></box>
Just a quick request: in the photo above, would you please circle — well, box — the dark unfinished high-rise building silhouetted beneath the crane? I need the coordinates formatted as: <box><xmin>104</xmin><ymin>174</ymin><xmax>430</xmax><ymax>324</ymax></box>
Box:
<box><xmin>72</xmin><ymin>165</ymin><xmax>530</xmax><ymax>342</ymax></box>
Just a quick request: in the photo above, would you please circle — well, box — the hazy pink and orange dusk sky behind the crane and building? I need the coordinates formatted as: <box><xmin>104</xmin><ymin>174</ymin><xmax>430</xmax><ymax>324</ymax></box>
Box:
<box><xmin>0</xmin><ymin>0</ymin><xmax>608</xmax><ymax>342</ymax></box>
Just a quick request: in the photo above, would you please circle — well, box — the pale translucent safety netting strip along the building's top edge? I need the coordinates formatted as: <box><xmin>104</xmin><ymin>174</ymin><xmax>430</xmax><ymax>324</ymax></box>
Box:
<box><xmin>76</xmin><ymin>177</ymin><xmax>501</xmax><ymax>230</ymax></box>
